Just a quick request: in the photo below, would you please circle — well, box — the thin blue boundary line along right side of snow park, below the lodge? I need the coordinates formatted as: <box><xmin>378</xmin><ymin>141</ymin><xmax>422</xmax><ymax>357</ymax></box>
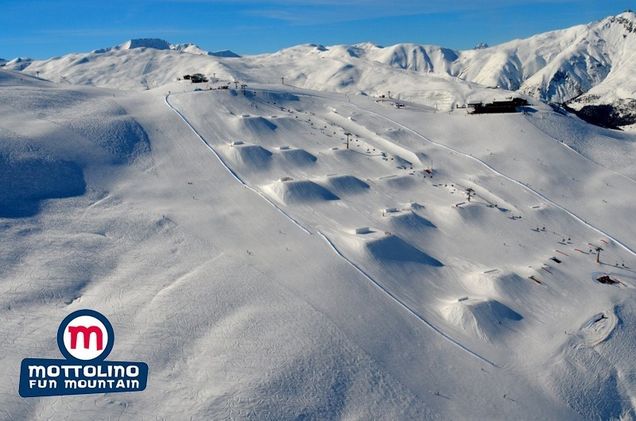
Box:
<box><xmin>351</xmin><ymin>103</ymin><xmax>636</xmax><ymax>257</ymax></box>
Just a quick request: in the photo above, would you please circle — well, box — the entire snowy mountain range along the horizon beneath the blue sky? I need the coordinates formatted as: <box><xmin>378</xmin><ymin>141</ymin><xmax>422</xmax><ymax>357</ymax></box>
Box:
<box><xmin>0</xmin><ymin>11</ymin><xmax>636</xmax><ymax>126</ymax></box>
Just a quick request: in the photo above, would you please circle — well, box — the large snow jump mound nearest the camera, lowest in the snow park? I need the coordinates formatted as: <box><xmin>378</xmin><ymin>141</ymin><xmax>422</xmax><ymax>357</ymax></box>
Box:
<box><xmin>440</xmin><ymin>297</ymin><xmax>523</xmax><ymax>341</ymax></box>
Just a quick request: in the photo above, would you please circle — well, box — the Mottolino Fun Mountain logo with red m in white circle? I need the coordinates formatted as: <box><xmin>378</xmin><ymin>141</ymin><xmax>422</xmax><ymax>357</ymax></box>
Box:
<box><xmin>19</xmin><ymin>310</ymin><xmax>148</xmax><ymax>398</ymax></box>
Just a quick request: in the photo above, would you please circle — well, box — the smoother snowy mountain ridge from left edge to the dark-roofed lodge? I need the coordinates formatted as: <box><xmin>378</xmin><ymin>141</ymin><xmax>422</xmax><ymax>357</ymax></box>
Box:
<box><xmin>0</xmin><ymin>40</ymin><xmax>506</xmax><ymax>110</ymax></box>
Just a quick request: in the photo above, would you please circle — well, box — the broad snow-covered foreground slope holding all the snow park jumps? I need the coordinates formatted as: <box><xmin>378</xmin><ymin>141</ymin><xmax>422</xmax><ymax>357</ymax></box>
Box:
<box><xmin>0</xmin><ymin>65</ymin><xmax>636</xmax><ymax>420</ymax></box>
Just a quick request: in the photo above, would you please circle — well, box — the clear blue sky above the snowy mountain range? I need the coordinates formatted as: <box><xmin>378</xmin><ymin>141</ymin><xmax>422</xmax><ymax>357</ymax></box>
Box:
<box><xmin>0</xmin><ymin>0</ymin><xmax>635</xmax><ymax>58</ymax></box>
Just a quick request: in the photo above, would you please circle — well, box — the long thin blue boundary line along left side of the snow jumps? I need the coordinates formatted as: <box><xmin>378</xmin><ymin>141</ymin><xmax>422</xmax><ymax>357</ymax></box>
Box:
<box><xmin>164</xmin><ymin>94</ymin><xmax>498</xmax><ymax>367</ymax></box>
